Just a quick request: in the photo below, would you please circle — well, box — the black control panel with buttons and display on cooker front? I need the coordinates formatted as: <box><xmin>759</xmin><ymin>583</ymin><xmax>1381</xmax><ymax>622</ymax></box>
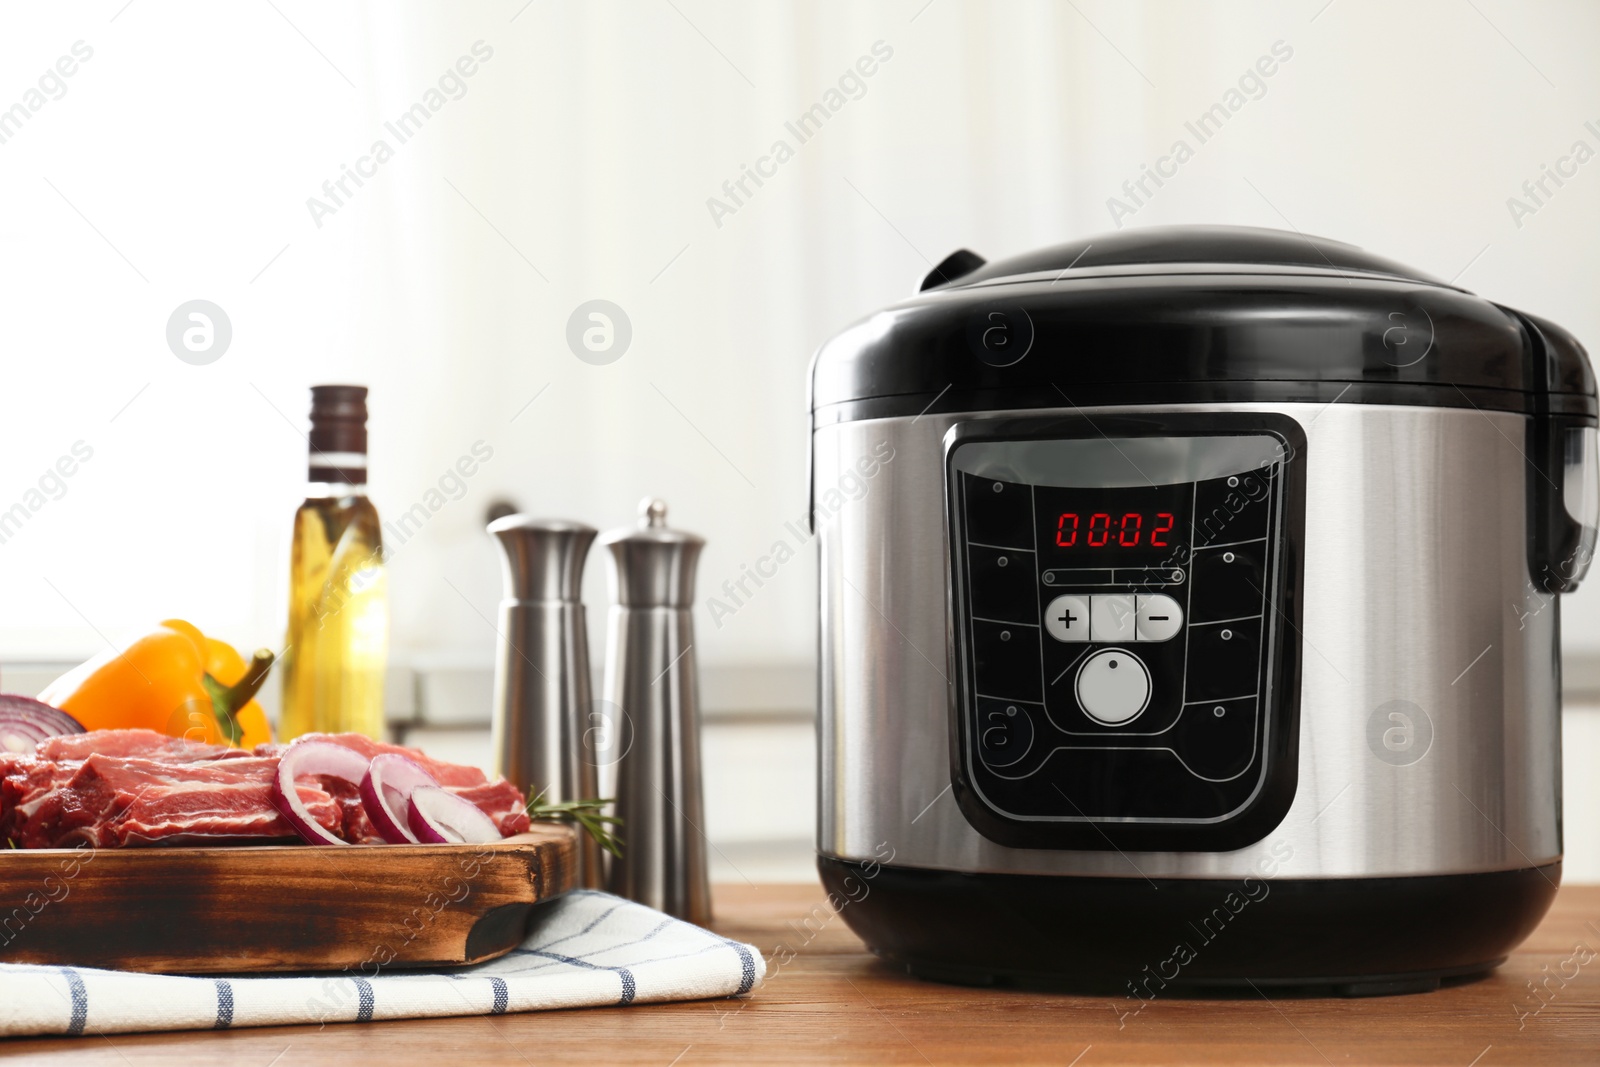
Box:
<box><xmin>947</xmin><ymin>414</ymin><xmax>1302</xmax><ymax>848</ymax></box>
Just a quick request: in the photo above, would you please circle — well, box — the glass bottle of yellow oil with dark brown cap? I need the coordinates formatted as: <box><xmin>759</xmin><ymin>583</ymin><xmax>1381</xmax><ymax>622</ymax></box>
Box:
<box><xmin>278</xmin><ymin>386</ymin><xmax>389</xmax><ymax>741</ymax></box>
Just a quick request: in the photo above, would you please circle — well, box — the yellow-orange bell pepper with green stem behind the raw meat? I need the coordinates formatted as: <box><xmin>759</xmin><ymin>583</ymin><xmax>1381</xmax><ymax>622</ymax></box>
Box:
<box><xmin>38</xmin><ymin>619</ymin><xmax>274</xmax><ymax>749</ymax></box>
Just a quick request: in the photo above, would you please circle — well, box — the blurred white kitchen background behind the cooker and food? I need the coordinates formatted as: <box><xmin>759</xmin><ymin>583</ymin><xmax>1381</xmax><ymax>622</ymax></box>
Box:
<box><xmin>0</xmin><ymin>0</ymin><xmax>1600</xmax><ymax>881</ymax></box>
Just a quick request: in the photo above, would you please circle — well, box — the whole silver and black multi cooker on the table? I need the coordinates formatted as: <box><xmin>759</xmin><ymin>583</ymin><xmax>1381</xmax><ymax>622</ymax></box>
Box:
<box><xmin>811</xmin><ymin>227</ymin><xmax>1600</xmax><ymax>1000</ymax></box>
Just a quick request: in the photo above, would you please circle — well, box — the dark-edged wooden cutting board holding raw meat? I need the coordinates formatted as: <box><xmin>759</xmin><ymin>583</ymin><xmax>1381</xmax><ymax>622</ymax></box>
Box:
<box><xmin>0</xmin><ymin>822</ymin><xmax>576</xmax><ymax>974</ymax></box>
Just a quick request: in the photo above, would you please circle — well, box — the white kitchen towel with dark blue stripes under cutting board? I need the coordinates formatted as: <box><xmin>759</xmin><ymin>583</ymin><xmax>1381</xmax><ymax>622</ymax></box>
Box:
<box><xmin>0</xmin><ymin>889</ymin><xmax>766</xmax><ymax>1037</ymax></box>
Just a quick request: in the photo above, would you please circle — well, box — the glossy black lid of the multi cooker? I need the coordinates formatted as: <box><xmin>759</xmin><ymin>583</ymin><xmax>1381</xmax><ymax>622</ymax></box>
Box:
<box><xmin>811</xmin><ymin>226</ymin><xmax>1595</xmax><ymax>422</ymax></box>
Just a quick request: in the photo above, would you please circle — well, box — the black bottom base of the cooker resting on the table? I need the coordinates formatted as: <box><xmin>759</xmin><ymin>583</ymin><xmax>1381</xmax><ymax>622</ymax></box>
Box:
<box><xmin>818</xmin><ymin>856</ymin><xmax>1562</xmax><ymax>1011</ymax></box>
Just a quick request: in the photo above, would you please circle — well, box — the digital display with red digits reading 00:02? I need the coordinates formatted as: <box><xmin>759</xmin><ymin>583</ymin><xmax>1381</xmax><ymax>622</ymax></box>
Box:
<box><xmin>1034</xmin><ymin>483</ymin><xmax>1194</xmax><ymax>568</ymax></box>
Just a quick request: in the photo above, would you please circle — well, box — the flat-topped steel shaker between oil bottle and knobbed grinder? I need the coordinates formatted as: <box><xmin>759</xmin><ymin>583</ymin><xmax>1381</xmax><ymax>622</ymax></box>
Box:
<box><xmin>488</xmin><ymin>515</ymin><xmax>605</xmax><ymax>888</ymax></box>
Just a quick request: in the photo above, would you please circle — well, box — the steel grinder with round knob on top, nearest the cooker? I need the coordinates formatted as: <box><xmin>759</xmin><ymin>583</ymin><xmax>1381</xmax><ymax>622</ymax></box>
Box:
<box><xmin>600</xmin><ymin>499</ymin><xmax>710</xmax><ymax>925</ymax></box>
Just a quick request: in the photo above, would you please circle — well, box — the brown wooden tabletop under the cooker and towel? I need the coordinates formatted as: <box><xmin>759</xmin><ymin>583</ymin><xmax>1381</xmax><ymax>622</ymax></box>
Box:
<box><xmin>0</xmin><ymin>885</ymin><xmax>1600</xmax><ymax>1067</ymax></box>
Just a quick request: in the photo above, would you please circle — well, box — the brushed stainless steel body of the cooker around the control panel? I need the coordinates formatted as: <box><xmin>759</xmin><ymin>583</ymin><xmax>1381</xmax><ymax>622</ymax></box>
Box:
<box><xmin>813</xmin><ymin>403</ymin><xmax>1562</xmax><ymax>880</ymax></box>
